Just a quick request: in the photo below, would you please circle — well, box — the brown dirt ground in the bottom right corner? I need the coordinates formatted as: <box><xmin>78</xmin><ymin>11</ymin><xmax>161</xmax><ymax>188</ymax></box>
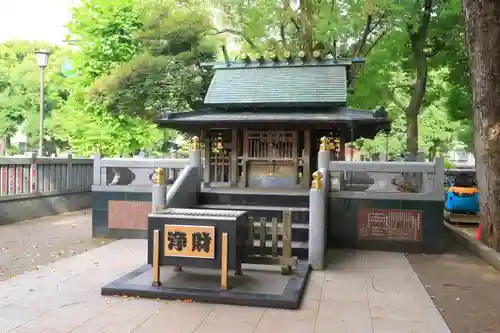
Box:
<box><xmin>407</xmin><ymin>230</ymin><xmax>500</xmax><ymax>333</ymax></box>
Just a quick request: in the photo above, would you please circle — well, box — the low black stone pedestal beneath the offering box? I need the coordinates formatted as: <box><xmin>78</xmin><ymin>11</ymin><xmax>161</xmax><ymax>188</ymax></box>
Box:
<box><xmin>101</xmin><ymin>262</ymin><xmax>310</xmax><ymax>309</ymax></box>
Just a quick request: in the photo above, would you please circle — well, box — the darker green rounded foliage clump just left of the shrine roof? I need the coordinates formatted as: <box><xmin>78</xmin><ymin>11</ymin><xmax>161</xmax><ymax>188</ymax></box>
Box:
<box><xmin>90</xmin><ymin>53</ymin><xmax>204</xmax><ymax>120</ymax></box>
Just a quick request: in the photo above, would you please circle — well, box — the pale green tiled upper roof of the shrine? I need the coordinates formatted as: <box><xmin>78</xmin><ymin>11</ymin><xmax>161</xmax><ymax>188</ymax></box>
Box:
<box><xmin>205</xmin><ymin>65</ymin><xmax>347</xmax><ymax>107</ymax></box>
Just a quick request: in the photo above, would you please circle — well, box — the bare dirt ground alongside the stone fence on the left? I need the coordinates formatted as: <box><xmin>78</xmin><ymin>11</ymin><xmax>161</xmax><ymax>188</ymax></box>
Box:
<box><xmin>0</xmin><ymin>210</ymin><xmax>110</xmax><ymax>281</ymax></box>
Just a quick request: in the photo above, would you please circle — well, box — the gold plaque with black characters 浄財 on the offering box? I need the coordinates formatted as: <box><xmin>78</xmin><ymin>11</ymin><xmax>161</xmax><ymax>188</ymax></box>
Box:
<box><xmin>164</xmin><ymin>224</ymin><xmax>215</xmax><ymax>259</ymax></box>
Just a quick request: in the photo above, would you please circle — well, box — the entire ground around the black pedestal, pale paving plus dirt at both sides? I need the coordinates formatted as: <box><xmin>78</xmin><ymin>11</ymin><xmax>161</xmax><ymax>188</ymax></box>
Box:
<box><xmin>0</xmin><ymin>211</ymin><xmax>500</xmax><ymax>333</ymax></box>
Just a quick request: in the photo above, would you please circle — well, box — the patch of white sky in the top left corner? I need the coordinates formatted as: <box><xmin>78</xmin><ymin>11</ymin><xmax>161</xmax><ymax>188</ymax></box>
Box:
<box><xmin>0</xmin><ymin>0</ymin><xmax>75</xmax><ymax>44</ymax></box>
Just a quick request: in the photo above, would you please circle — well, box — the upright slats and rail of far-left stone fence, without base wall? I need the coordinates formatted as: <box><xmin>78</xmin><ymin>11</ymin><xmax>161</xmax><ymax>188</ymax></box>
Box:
<box><xmin>0</xmin><ymin>154</ymin><xmax>93</xmax><ymax>198</ymax></box>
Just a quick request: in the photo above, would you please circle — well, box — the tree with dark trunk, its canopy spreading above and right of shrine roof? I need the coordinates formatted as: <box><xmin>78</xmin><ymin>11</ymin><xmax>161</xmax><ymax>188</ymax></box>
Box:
<box><xmin>212</xmin><ymin>0</ymin><xmax>468</xmax><ymax>159</ymax></box>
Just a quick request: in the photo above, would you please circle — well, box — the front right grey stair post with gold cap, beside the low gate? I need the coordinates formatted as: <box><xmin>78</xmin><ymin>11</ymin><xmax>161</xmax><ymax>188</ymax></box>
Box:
<box><xmin>309</xmin><ymin>171</ymin><xmax>327</xmax><ymax>270</ymax></box>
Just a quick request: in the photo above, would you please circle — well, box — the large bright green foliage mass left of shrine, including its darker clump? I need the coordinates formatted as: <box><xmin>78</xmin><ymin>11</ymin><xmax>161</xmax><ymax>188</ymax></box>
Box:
<box><xmin>49</xmin><ymin>0</ymin><xmax>215</xmax><ymax>155</ymax></box>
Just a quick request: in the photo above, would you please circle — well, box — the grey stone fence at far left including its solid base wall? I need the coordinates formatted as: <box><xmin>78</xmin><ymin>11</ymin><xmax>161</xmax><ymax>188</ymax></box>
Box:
<box><xmin>0</xmin><ymin>154</ymin><xmax>93</xmax><ymax>224</ymax></box>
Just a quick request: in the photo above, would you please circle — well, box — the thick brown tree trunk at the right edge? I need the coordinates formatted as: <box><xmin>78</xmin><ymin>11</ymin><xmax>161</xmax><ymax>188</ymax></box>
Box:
<box><xmin>462</xmin><ymin>0</ymin><xmax>500</xmax><ymax>251</ymax></box>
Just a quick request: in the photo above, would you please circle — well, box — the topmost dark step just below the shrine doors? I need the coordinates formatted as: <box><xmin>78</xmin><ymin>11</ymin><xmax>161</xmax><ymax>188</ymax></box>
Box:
<box><xmin>198</xmin><ymin>189</ymin><xmax>309</xmax><ymax>208</ymax></box>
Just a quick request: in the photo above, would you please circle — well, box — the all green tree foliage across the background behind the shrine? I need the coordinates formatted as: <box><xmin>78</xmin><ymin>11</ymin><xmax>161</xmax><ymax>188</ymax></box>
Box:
<box><xmin>0</xmin><ymin>0</ymin><xmax>473</xmax><ymax>158</ymax></box>
